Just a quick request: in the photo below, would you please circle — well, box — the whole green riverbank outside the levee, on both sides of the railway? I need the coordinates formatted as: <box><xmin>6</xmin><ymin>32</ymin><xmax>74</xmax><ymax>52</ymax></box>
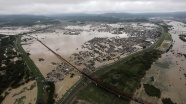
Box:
<box><xmin>78</xmin><ymin>50</ymin><xmax>162</xmax><ymax>104</ymax></box>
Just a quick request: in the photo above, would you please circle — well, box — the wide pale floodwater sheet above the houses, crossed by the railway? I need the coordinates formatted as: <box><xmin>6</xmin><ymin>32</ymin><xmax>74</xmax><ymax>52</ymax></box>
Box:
<box><xmin>23</xmin><ymin>27</ymin><xmax>128</xmax><ymax>77</ymax></box>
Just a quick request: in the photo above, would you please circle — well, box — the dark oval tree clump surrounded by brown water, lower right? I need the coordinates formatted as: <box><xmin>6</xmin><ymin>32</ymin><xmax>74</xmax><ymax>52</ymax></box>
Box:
<box><xmin>143</xmin><ymin>84</ymin><xmax>161</xmax><ymax>98</ymax></box>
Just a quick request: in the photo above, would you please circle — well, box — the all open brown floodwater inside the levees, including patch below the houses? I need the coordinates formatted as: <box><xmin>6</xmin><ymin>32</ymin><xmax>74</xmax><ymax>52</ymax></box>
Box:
<box><xmin>22</xmin><ymin>25</ymin><xmax>128</xmax><ymax>101</ymax></box>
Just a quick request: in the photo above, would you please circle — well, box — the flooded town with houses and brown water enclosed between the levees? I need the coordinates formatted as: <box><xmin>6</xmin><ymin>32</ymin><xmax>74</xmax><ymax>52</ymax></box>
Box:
<box><xmin>18</xmin><ymin>23</ymin><xmax>161</xmax><ymax>102</ymax></box>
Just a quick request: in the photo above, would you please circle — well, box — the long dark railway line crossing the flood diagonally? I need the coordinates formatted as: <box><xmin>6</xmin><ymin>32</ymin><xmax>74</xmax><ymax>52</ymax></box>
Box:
<box><xmin>26</xmin><ymin>35</ymin><xmax>151</xmax><ymax>104</ymax></box>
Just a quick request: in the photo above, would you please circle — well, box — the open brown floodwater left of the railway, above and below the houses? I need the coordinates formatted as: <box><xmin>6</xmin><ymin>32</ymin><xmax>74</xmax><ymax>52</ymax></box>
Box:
<box><xmin>23</xmin><ymin>36</ymin><xmax>80</xmax><ymax>101</ymax></box>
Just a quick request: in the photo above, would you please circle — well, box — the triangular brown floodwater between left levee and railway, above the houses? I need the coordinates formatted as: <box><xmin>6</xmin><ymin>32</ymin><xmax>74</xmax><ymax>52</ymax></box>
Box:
<box><xmin>22</xmin><ymin>35</ymin><xmax>61</xmax><ymax>77</ymax></box>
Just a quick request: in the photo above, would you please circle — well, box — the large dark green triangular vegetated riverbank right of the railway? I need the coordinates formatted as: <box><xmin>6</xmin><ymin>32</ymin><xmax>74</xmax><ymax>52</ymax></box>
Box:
<box><xmin>99</xmin><ymin>50</ymin><xmax>161</xmax><ymax>95</ymax></box>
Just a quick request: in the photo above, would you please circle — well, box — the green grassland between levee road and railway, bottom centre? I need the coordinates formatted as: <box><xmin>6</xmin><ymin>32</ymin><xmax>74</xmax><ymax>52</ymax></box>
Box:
<box><xmin>77</xmin><ymin>84</ymin><xmax>129</xmax><ymax>104</ymax></box>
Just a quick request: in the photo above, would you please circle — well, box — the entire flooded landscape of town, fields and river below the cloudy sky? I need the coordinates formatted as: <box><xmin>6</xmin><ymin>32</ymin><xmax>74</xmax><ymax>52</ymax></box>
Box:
<box><xmin>0</xmin><ymin>10</ymin><xmax>186</xmax><ymax>104</ymax></box>
